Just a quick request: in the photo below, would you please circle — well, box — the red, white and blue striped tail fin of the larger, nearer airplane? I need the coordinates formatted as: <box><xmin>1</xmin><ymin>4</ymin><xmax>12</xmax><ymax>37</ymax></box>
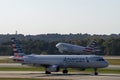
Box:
<box><xmin>11</xmin><ymin>38</ymin><xmax>24</xmax><ymax>62</ymax></box>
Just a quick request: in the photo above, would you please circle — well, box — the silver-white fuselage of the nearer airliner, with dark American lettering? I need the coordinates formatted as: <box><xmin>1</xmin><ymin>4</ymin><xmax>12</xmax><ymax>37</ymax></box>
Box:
<box><xmin>23</xmin><ymin>55</ymin><xmax>108</xmax><ymax>68</ymax></box>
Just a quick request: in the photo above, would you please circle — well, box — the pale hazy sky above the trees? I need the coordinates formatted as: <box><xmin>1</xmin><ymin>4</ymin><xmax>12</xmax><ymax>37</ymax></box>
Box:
<box><xmin>0</xmin><ymin>0</ymin><xmax>120</xmax><ymax>34</ymax></box>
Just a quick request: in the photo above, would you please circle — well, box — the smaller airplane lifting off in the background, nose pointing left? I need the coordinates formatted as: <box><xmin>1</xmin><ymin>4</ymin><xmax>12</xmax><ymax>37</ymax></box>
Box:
<box><xmin>56</xmin><ymin>39</ymin><xmax>100</xmax><ymax>53</ymax></box>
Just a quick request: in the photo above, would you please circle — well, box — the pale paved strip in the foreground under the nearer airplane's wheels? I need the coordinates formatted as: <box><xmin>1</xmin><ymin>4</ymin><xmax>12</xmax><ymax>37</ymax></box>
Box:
<box><xmin>0</xmin><ymin>71</ymin><xmax>120</xmax><ymax>80</ymax></box>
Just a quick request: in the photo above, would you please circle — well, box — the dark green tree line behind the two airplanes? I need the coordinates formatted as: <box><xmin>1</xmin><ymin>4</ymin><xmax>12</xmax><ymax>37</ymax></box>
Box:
<box><xmin>0</xmin><ymin>35</ymin><xmax>120</xmax><ymax>55</ymax></box>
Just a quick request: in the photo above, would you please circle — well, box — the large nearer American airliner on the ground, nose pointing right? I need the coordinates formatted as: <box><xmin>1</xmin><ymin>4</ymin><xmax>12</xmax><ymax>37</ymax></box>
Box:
<box><xmin>11</xmin><ymin>38</ymin><xmax>109</xmax><ymax>75</ymax></box>
